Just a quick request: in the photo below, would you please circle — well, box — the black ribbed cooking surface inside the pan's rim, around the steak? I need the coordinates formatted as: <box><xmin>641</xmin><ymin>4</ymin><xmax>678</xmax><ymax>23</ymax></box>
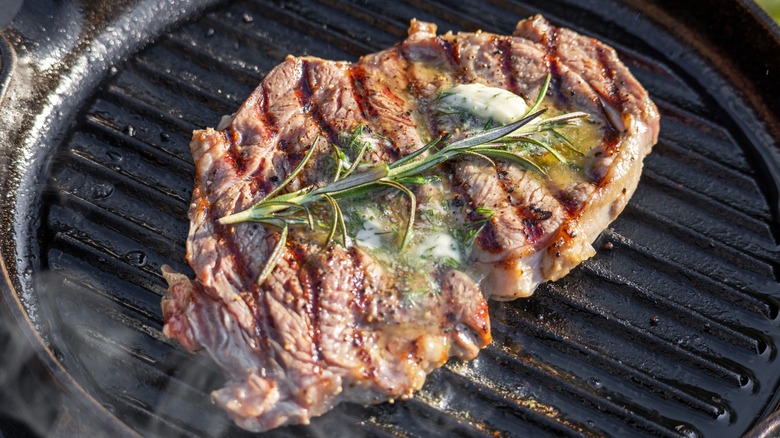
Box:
<box><xmin>34</xmin><ymin>0</ymin><xmax>780</xmax><ymax>436</ymax></box>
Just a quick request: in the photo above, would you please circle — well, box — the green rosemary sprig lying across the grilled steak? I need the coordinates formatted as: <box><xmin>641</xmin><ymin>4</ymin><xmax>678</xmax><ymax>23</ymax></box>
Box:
<box><xmin>219</xmin><ymin>77</ymin><xmax>586</xmax><ymax>283</ymax></box>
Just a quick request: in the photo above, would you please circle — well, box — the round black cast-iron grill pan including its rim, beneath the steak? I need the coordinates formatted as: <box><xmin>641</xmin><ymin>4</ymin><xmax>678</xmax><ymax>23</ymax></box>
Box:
<box><xmin>0</xmin><ymin>0</ymin><xmax>780</xmax><ymax>436</ymax></box>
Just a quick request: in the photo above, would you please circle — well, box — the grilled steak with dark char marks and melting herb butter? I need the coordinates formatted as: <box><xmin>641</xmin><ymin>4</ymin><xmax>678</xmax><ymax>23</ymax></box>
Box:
<box><xmin>162</xmin><ymin>16</ymin><xmax>658</xmax><ymax>431</ymax></box>
